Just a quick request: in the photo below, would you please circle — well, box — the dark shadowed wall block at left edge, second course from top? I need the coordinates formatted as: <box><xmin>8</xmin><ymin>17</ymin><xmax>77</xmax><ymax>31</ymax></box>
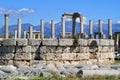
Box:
<box><xmin>0</xmin><ymin>46</ymin><xmax>15</xmax><ymax>53</ymax></box>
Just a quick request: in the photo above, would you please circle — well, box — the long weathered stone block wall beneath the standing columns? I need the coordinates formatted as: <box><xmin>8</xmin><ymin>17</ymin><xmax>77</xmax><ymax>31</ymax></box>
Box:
<box><xmin>0</xmin><ymin>39</ymin><xmax>114</xmax><ymax>65</ymax></box>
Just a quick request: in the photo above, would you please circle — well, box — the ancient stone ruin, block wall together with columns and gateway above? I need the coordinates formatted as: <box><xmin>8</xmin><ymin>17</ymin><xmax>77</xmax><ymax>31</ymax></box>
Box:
<box><xmin>0</xmin><ymin>13</ymin><xmax>115</xmax><ymax>65</ymax></box>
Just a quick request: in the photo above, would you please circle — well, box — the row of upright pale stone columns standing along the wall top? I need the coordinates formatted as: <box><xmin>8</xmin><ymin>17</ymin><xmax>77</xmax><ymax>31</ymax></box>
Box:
<box><xmin>4</xmin><ymin>14</ymin><xmax>112</xmax><ymax>39</ymax></box>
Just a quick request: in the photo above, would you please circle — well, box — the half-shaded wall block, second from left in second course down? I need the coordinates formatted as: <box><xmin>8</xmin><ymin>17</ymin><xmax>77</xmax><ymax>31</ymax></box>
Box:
<box><xmin>15</xmin><ymin>46</ymin><xmax>31</xmax><ymax>53</ymax></box>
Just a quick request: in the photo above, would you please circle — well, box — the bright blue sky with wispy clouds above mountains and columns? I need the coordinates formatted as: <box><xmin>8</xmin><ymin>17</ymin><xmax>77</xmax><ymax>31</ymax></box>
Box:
<box><xmin>0</xmin><ymin>0</ymin><xmax>120</xmax><ymax>26</ymax></box>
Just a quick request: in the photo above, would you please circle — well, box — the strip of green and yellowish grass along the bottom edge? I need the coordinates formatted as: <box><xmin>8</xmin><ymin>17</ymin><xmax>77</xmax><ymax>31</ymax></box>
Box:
<box><xmin>7</xmin><ymin>75</ymin><xmax>120</xmax><ymax>80</ymax></box>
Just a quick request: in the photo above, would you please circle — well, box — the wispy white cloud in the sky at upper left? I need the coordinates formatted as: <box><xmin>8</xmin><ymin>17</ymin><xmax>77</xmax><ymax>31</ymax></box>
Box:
<box><xmin>0</xmin><ymin>8</ymin><xmax>35</xmax><ymax>16</ymax></box>
